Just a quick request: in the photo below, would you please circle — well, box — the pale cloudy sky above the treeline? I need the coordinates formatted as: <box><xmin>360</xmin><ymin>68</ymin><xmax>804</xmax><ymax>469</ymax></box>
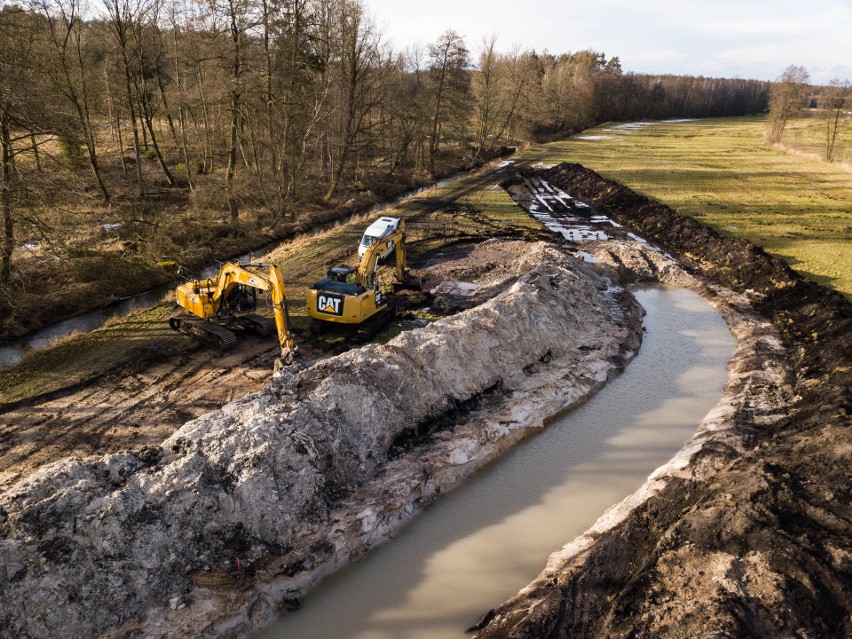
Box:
<box><xmin>364</xmin><ymin>0</ymin><xmax>852</xmax><ymax>84</ymax></box>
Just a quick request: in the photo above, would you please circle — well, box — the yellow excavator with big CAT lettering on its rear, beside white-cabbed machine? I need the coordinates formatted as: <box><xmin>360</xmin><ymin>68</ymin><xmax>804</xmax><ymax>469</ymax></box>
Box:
<box><xmin>307</xmin><ymin>223</ymin><xmax>417</xmax><ymax>338</ymax></box>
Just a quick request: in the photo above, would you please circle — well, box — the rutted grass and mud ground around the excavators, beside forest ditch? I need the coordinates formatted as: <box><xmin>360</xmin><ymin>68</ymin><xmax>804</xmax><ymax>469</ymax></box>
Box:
<box><xmin>0</xmin><ymin>161</ymin><xmax>547</xmax><ymax>486</ymax></box>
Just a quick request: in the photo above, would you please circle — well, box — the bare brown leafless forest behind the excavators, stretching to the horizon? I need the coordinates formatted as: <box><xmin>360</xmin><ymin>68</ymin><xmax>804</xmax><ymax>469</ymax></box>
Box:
<box><xmin>0</xmin><ymin>0</ymin><xmax>770</xmax><ymax>337</ymax></box>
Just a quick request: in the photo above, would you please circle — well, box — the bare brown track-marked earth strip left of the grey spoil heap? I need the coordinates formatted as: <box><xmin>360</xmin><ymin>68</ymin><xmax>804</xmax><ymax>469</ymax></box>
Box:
<box><xmin>0</xmin><ymin>338</ymin><xmax>276</xmax><ymax>486</ymax></box>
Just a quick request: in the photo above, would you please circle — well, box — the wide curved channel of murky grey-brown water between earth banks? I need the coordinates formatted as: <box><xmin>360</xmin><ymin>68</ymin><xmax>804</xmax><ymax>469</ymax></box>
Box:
<box><xmin>254</xmin><ymin>288</ymin><xmax>734</xmax><ymax>639</ymax></box>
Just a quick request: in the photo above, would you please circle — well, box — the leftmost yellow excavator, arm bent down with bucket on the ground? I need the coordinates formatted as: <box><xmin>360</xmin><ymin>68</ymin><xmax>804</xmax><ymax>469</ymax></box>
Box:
<box><xmin>169</xmin><ymin>262</ymin><xmax>298</xmax><ymax>370</ymax></box>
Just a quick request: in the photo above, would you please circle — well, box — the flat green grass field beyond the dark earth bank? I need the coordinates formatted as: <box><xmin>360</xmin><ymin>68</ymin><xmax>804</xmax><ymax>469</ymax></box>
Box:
<box><xmin>526</xmin><ymin>117</ymin><xmax>852</xmax><ymax>297</ymax></box>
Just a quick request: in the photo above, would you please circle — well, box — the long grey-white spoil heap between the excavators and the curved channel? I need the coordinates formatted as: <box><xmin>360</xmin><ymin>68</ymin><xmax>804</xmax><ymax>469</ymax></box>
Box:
<box><xmin>0</xmin><ymin>242</ymin><xmax>641</xmax><ymax>637</ymax></box>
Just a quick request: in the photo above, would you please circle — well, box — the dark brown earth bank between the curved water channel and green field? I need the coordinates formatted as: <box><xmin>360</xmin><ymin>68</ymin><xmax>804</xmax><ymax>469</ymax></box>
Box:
<box><xmin>477</xmin><ymin>164</ymin><xmax>852</xmax><ymax>639</ymax></box>
